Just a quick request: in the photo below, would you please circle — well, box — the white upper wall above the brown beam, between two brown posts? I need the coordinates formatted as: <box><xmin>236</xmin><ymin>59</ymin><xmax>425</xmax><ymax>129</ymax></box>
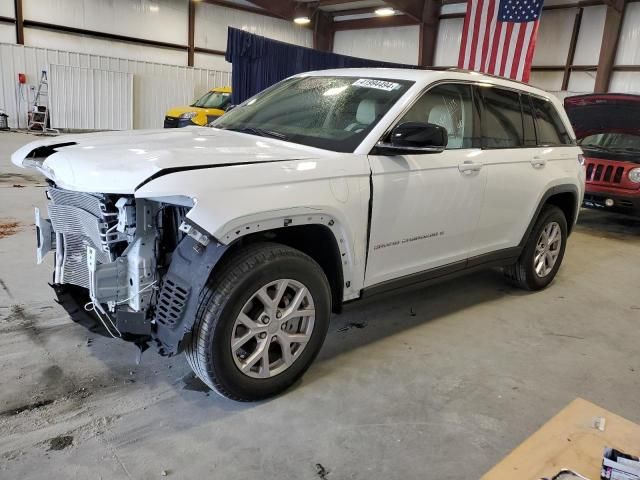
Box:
<box><xmin>23</xmin><ymin>0</ymin><xmax>188</xmax><ymax>45</ymax></box>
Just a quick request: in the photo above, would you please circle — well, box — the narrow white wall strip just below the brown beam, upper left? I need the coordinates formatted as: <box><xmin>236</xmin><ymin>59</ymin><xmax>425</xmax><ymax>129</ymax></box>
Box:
<box><xmin>24</xmin><ymin>28</ymin><xmax>187</xmax><ymax>65</ymax></box>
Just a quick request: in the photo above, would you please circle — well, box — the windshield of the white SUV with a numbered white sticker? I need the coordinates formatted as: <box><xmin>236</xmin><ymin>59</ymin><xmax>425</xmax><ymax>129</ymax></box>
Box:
<box><xmin>212</xmin><ymin>77</ymin><xmax>413</xmax><ymax>152</ymax></box>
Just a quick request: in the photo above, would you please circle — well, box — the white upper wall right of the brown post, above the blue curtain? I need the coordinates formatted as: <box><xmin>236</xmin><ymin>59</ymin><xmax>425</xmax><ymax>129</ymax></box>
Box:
<box><xmin>195</xmin><ymin>2</ymin><xmax>313</xmax><ymax>50</ymax></box>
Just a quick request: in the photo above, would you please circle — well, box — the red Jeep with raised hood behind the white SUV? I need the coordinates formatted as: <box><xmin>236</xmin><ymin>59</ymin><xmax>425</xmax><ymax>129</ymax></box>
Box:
<box><xmin>564</xmin><ymin>93</ymin><xmax>640</xmax><ymax>216</ymax></box>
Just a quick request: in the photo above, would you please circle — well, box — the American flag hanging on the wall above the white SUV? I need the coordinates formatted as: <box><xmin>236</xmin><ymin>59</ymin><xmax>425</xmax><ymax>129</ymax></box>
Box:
<box><xmin>458</xmin><ymin>0</ymin><xmax>543</xmax><ymax>82</ymax></box>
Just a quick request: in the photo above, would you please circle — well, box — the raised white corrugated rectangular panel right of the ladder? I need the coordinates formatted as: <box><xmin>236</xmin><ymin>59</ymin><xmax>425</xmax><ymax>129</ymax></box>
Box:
<box><xmin>48</xmin><ymin>65</ymin><xmax>133</xmax><ymax>130</ymax></box>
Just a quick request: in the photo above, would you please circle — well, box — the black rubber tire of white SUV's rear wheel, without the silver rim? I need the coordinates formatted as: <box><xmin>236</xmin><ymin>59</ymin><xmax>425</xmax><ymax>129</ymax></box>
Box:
<box><xmin>504</xmin><ymin>205</ymin><xmax>567</xmax><ymax>290</ymax></box>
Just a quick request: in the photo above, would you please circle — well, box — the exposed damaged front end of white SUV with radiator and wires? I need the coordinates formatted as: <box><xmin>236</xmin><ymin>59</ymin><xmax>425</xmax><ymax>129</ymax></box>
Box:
<box><xmin>36</xmin><ymin>183</ymin><xmax>192</xmax><ymax>350</ymax></box>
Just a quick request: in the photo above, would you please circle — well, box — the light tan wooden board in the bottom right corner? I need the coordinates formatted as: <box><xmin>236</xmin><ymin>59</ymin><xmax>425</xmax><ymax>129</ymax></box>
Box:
<box><xmin>482</xmin><ymin>398</ymin><xmax>640</xmax><ymax>480</ymax></box>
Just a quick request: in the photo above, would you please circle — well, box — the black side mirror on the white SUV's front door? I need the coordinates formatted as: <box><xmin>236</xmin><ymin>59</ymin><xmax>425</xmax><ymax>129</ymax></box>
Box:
<box><xmin>376</xmin><ymin>122</ymin><xmax>449</xmax><ymax>155</ymax></box>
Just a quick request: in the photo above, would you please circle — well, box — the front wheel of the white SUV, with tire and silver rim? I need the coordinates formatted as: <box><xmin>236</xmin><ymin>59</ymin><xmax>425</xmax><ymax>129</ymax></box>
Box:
<box><xmin>186</xmin><ymin>243</ymin><xmax>331</xmax><ymax>401</ymax></box>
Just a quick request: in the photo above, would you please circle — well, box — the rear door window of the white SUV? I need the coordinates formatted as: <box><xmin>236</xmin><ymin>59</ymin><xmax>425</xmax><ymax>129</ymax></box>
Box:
<box><xmin>480</xmin><ymin>87</ymin><xmax>524</xmax><ymax>148</ymax></box>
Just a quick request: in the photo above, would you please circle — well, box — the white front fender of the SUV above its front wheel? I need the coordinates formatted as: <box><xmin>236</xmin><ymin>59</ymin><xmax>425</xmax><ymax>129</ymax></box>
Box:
<box><xmin>135</xmin><ymin>154</ymin><xmax>370</xmax><ymax>300</ymax></box>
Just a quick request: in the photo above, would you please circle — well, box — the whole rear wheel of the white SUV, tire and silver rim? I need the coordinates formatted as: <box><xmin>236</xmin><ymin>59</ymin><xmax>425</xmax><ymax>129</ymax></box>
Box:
<box><xmin>504</xmin><ymin>205</ymin><xmax>567</xmax><ymax>290</ymax></box>
